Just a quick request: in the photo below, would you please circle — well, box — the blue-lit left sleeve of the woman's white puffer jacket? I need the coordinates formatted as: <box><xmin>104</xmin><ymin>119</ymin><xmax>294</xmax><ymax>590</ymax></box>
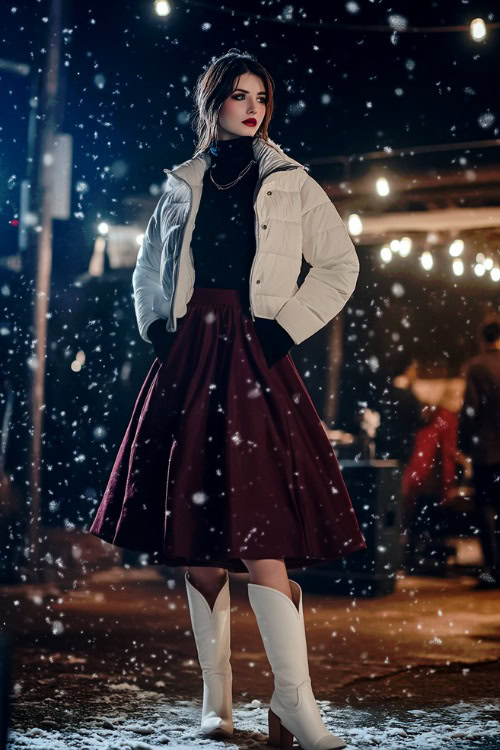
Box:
<box><xmin>132</xmin><ymin>193</ymin><xmax>166</xmax><ymax>344</ymax></box>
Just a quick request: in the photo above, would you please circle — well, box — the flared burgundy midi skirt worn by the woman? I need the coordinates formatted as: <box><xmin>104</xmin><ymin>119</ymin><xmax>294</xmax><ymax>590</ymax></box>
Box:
<box><xmin>89</xmin><ymin>287</ymin><xmax>366</xmax><ymax>573</ymax></box>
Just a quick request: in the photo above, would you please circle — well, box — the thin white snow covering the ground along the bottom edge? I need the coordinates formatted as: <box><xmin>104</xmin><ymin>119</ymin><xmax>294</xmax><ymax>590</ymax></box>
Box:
<box><xmin>7</xmin><ymin>683</ymin><xmax>500</xmax><ymax>750</ymax></box>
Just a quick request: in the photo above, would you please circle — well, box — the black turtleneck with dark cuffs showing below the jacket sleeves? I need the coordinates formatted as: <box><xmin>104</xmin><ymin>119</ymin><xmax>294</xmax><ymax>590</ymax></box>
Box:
<box><xmin>148</xmin><ymin>135</ymin><xmax>294</xmax><ymax>366</ymax></box>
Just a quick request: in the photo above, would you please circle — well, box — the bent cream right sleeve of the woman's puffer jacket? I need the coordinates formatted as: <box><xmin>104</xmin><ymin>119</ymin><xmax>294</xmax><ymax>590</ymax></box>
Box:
<box><xmin>275</xmin><ymin>174</ymin><xmax>359</xmax><ymax>344</ymax></box>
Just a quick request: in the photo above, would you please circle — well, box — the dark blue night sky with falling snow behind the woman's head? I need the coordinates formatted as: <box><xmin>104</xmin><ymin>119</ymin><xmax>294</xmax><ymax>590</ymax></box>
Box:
<box><xmin>0</xmin><ymin>0</ymin><xmax>498</xmax><ymax>234</ymax></box>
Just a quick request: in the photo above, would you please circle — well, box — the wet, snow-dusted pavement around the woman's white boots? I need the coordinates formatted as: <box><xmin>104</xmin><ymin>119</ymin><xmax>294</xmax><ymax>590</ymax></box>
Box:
<box><xmin>0</xmin><ymin>566</ymin><xmax>500</xmax><ymax>750</ymax></box>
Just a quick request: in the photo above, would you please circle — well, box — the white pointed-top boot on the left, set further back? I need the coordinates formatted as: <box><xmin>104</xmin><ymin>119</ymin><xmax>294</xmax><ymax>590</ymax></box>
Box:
<box><xmin>185</xmin><ymin>571</ymin><xmax>233</xmax><ymax>737</ymax></box>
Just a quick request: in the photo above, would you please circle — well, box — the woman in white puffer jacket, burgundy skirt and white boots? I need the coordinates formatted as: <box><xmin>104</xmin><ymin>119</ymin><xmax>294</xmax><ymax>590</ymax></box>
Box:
<box><xmin>90</xmin><ymin>50</ymin><xmax>366</xmax><ymax>750</ymax></box>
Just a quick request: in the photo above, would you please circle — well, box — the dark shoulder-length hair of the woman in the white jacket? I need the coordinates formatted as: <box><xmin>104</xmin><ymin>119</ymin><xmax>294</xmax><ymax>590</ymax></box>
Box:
<box><xmin>191</xmin><ymin>47</ymin><xmax>274</xmax><ymax>157</ymax></box>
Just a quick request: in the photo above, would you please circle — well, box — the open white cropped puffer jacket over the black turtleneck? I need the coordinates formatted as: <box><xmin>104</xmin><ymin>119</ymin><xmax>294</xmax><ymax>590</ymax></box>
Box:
<box><xmin>132</xmin><ymin>136</ymin><xmax>359</xmax><ymax>344</ymax></box>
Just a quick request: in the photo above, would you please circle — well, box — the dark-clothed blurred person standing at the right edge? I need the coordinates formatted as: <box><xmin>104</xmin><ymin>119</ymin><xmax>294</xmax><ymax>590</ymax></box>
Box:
<box><xmin>459</xmin><ymin>321</ymin><xmax>500</xmax><ymax>588</ymax></box>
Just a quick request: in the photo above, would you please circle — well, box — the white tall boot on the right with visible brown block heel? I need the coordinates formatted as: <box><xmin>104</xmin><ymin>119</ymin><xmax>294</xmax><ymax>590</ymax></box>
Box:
<box><xmin>248</xmin><ymin>581</ymin><xmax>346</xmax><ymax>750</ymax></box>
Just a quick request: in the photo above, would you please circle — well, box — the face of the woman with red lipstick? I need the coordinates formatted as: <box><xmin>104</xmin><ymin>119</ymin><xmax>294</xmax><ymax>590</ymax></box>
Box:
<box><xmin>217</xmin><ymin>73</ymin><xmax>267</xmax><ymax>141</ymax></box>
